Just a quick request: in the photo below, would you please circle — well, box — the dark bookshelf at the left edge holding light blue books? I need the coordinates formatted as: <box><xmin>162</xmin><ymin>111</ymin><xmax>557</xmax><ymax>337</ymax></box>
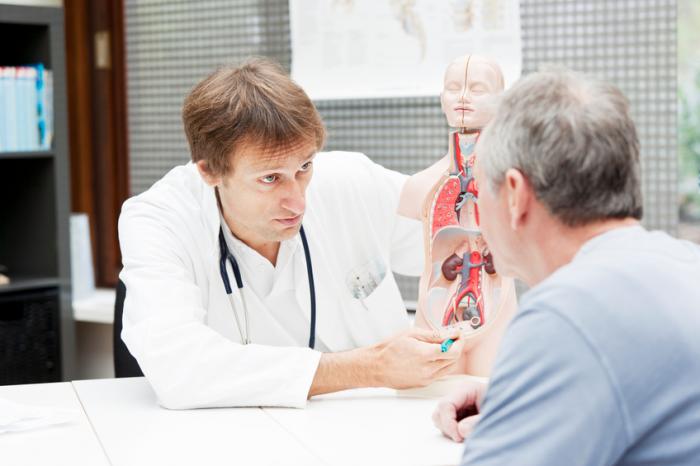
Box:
<box><xmin>0</xmin><ymin>4</ymin><xmax>75</xmax><ymax>384</ymax></box>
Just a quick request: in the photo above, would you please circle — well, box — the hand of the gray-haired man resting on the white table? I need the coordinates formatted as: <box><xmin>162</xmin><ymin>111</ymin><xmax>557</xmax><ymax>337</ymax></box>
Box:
<box><xmin>433</xmin><ymin>380</ymin><xmax>487</xmax><ymax>442</ymax></box>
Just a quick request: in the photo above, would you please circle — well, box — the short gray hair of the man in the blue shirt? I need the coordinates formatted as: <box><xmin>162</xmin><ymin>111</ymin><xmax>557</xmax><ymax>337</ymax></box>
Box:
<box><xmin>477</xmin><ymin>69</ymin><xmax>642</xmax><ymax>226</ymax></box>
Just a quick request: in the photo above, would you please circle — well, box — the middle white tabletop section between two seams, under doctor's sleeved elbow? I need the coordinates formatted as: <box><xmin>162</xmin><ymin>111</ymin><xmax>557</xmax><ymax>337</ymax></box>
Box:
<box><xmin>73</xmin><ymin>377</ymin><xmax>324</xmax><ymax>466</ymax></box>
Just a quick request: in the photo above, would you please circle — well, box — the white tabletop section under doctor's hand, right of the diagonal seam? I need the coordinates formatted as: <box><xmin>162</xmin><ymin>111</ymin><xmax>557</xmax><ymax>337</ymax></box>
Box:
<box><xmin>263</xmin><ymin>388</ymin><xmax>463</xmax><ymax>466</ymax></box>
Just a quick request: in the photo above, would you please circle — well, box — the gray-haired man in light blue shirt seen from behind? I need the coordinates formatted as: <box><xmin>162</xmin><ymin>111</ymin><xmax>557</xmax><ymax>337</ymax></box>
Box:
<box><xmin>433</xmin><ymin>71</ymin><xmax>700</xmax><ymax>466</ymax></box>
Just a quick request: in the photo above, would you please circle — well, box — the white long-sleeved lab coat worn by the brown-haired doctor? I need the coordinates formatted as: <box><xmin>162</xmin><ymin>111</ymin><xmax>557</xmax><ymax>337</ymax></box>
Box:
<box><xmin>119</xmin><ymin>152</ymin><xmax>423</xmax><ymax>408</ymax></box>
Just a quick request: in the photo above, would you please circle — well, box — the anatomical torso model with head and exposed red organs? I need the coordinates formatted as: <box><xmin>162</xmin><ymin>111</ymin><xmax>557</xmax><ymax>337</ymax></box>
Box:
<box><xmin>399</xmin><ymin>55</ymin><xmax>516</xmax><ymax>375</ymax></box>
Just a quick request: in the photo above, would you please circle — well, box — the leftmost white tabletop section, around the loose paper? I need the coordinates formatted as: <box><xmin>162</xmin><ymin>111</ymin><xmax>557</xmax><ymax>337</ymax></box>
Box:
<box><xmin>0</xmin><ymin>383</ymin><xmax>109</xmax><ymax>466</ymax></box>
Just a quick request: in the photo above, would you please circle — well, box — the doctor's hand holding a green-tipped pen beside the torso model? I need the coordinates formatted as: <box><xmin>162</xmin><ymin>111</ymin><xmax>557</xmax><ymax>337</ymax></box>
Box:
<box><xmin>368</xmin><ymin>328</ymin><xmax>464</xmax><ymax>389</ymax></box>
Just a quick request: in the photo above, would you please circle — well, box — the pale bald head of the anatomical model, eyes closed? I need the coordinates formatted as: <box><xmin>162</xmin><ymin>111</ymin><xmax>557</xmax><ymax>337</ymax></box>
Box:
<box><xmin>440</xmin><ymin>55</ymin><xmax>503</xmax><ymax>130</ymax></box>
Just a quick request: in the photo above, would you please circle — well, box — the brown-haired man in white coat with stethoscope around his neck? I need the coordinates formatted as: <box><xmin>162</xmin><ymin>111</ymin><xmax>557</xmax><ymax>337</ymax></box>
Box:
<box><xmin>119</xmin><ymin>59</ymin><xmax>461</xmax><ymax>408</ymax></box>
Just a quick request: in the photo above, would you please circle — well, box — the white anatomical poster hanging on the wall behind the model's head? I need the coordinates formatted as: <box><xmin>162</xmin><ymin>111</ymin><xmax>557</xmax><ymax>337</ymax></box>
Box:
<box><xmin>289</xmin><ymin>0</ymin><xmax>521</xmax><ymax>99</ymax></box>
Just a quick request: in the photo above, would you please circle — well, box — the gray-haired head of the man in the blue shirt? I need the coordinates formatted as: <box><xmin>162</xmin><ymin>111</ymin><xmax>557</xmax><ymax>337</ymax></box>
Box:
<box><xmin>476</xmin><ymin>70</ymin><xmax>642</xmax><ymax>282</ymax></box>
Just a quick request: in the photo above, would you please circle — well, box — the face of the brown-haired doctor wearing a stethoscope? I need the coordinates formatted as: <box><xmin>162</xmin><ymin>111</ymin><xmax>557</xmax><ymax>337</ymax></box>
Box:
<box><xmin>217</xmin><ymin>143</ymin><xmax>316</xmax><ymax>247</ymax></box>
